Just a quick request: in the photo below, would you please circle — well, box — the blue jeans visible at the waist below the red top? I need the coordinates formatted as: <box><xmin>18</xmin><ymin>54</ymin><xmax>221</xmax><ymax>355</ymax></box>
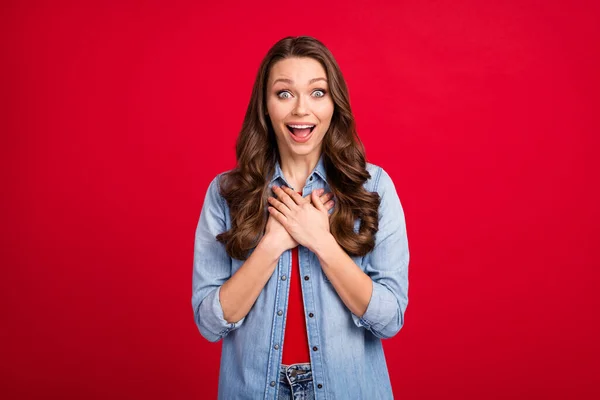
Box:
<box><xmin>278</xmin><ymin>363</ymin><xmax>315</xmax><ymax>400</ymax></box>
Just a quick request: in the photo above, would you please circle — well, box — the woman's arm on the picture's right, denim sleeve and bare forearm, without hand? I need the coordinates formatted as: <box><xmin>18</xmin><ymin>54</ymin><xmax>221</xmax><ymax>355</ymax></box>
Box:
<box><xmin>315</xmin><ymin>169</ymin><xmax>409</xmax><ymax>339</ymax></box>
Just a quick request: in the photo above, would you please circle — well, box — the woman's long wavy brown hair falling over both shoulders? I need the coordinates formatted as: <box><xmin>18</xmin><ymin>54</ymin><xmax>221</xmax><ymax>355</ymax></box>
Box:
<box><xmin>216</xmin><ymin>36</ymin><xmax>380</xmax><ymax>260</ymax></box>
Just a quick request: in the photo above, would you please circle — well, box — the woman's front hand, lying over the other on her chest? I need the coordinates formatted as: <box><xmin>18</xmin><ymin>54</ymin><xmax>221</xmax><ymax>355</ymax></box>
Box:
<box><xmin>268</xmin><ymin>186</ymin><xmax>331</xmax><ymax>251</ymax></box>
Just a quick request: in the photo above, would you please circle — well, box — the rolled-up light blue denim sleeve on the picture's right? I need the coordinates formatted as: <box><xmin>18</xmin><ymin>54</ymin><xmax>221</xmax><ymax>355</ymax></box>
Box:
<box><xmin>352</xmin><ymin>168</ymin><xmax>410</xmax><ymax>339</ymax></box>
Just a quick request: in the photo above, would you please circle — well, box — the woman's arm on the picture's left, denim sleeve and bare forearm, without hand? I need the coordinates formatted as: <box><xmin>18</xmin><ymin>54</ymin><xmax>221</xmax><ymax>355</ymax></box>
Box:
<box><xmin>192</xmin><ymin>176</ymin><xmax>280</xmax><ymax>342</ymax></box>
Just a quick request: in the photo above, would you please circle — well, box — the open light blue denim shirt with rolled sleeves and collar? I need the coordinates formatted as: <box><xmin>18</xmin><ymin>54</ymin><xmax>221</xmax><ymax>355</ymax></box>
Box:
<box><xmin>192</xmin><ymin>157</ymin><xmax>409</xmax><ymax>400</ymax></box>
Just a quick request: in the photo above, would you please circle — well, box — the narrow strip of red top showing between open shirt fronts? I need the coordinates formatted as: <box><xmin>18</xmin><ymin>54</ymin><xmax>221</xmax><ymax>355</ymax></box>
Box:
<box><xmin>281</xmin><ymin>192</ymin><xmax>310</xmax><ymax>365</ymax></box>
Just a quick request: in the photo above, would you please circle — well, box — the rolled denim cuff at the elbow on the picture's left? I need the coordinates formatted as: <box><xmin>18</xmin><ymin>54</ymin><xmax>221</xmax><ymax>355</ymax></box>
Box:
<box><xmin>196</xmin><ymin>286</ymin><xmax>246</xmax><ymax>342</ymax></box>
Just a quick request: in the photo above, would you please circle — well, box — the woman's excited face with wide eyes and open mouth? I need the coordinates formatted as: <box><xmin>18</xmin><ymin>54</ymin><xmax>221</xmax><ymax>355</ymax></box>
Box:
<box><xmin>266</xmin><ymin>57</ymin><xmax>334</xmax><ymax>157</ymax></box>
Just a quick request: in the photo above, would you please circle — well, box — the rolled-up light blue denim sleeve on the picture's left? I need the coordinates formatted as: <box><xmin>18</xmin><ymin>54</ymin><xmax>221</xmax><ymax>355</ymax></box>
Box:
<box><xmin>192</xmin><ymin>175</ymin><xmax>245</xmax><ymax>342</ymax></box>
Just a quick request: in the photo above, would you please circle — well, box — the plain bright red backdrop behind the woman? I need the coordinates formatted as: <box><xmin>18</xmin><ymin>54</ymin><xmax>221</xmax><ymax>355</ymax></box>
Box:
<box><xmin>0</xmin><ymin>0</ymin><xmax>600</xmax><ymax>400</ymax></box>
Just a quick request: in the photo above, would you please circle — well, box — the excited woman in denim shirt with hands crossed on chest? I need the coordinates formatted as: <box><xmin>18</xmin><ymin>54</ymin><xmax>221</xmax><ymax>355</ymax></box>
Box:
<box><xmin>192</xmin><ymin>36</ymin><xmax>409</xmax><ymax>400</ymax></box>
